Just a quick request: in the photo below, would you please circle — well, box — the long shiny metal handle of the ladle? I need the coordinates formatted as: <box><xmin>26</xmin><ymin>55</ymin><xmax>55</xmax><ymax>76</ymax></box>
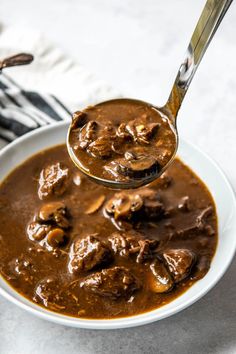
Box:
<box><xmin>164</xmin><ymin>0</ymin><xmax>233</xmax><ymax>121</ymax></box>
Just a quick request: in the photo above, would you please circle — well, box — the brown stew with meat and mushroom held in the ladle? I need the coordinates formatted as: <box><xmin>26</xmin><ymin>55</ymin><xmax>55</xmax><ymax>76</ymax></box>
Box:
<box><xmin>69</xmin><ymin>99</ymin><xmax>176</xmax><ymax>186</ymax></box>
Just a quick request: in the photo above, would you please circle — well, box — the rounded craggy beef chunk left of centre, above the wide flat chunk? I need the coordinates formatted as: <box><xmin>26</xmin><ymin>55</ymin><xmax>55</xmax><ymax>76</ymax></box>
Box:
<box><xmin>68</xmin><ymin>236</ymin><xmax>112</xmax><ymax>273</ymax></box>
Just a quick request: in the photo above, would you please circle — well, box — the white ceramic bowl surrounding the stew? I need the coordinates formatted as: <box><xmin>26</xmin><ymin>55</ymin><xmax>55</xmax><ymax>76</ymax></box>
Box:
<box><xmin>0</xmin><ymin>122</ymin><xmax>236</xmax><ymax>329</ymax></box>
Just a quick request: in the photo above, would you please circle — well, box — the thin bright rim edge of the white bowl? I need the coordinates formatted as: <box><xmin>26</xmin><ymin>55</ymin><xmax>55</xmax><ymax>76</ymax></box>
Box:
<box><xmin>0</xmin><ymin>121</ymin><xmax>236</xmax><ymax>329</ymax></box>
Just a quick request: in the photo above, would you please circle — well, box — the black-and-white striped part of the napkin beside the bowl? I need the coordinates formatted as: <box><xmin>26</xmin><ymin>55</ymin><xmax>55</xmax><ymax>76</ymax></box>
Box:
<box><xmin>0</xmin><ymin>74</ymin><xmax>71</xmax><ymax>143</ymax></box>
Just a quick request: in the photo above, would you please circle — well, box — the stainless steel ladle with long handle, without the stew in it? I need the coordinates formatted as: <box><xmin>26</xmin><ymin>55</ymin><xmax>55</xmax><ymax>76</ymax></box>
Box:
<box><xmin>67</xmin><ymin>0</ymin><xmax>233</xmax><ymax>189</ymax></box>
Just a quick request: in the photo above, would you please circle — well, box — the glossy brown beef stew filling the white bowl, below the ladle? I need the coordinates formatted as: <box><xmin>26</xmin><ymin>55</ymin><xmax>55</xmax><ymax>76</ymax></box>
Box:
<box><xmin>0</xmin><ymin>145</ymin><xmax>217</xmax><ymax>319</ymax></box>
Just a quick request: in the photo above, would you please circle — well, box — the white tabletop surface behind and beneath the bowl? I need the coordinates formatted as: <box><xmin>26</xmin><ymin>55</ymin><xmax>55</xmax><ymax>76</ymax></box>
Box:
<box><xmin>0</xmin><ymin>0</ymin><xmax>236</xmax><ymax>354</ymax></box>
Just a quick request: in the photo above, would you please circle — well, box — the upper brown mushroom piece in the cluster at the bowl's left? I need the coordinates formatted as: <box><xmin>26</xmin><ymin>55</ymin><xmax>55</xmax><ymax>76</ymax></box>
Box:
<box><xmin>36</xmin><ymin>202</ymin><xmax>70</xmax><ymax>229</ymax></box>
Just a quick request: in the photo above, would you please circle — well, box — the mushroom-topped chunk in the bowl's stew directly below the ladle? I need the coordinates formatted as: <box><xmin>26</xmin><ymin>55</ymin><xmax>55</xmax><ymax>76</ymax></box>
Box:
<box><xmin>105</xmin><ymin>188</ymin><xmax>164</xmax><ymax>221</ymax></box>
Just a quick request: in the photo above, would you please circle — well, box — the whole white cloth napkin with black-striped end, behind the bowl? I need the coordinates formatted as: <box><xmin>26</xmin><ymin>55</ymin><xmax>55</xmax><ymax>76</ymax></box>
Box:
<box><xmin>0</xmin><ymin>24</ymin><xmax>118</xmax><ymax>147</ymax></box>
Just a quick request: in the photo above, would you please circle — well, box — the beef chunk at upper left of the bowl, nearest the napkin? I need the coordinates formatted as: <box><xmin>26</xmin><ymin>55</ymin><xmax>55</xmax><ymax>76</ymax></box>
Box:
<box><xmin>38</xmin><ymin>162</ymin><xmax>69</xmax><ymax>199</ymax></box>
